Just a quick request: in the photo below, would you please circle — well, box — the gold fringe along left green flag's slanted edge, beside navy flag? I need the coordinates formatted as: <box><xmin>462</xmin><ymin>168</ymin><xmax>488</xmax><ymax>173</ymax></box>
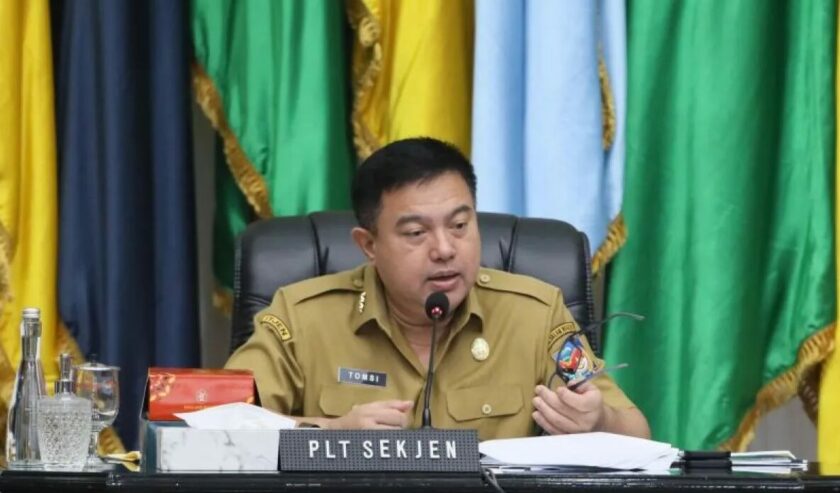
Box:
<box><xmin>191</xmin><ymin>61</ymin><xmax>273</xmax><ymax>218</ymax></box>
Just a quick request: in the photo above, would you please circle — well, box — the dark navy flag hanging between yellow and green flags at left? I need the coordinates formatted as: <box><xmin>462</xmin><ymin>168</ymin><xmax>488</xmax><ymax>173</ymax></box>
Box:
<box><xmin>52</xmin><ymin>0</ymin><xmax>200</xmax><ymax>448</ymax></box>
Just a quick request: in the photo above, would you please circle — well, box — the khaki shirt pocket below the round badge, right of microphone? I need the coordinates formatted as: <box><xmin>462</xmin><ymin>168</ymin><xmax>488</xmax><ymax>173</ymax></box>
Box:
<box><xmin>446</xmin><ymin>385</ymin><xmax>523</xmax><ymax>422</ymax></box>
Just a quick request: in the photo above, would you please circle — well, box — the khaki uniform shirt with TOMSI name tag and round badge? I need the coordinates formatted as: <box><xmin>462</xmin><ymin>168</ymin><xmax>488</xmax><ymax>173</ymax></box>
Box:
<box><xmin>226</xmin><ymin>265</ymin><xmax>634</xmax><ymax>440</ymax></box>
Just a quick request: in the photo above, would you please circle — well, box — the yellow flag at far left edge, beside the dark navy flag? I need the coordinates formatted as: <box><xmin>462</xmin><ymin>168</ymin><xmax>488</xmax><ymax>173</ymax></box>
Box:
<box><xmin>0</xmin><ymin>0</ymin><xmax>58</xmax><ymax>408</ymax></box>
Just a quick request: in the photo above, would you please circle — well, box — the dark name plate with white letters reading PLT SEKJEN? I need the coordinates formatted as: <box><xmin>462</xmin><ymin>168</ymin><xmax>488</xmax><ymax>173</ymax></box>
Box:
<box><xmin>279</xmin><ymin>429</ymin><xmax>481</xmax><ymax>472</ymax></box>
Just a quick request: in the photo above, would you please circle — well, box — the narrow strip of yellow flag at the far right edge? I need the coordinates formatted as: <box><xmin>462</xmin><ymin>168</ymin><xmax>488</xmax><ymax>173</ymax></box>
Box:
<box><xmin>817</xmin><ymin>7</ymin><xmax>840</xmax><ymax>465</ymax></box>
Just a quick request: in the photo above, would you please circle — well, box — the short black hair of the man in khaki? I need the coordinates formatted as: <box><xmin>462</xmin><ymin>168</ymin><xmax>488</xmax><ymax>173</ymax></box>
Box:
<box><xmin>353</xmin><ymin>137</ymin><xmax>475</xmax><ymax>231</ymax></box>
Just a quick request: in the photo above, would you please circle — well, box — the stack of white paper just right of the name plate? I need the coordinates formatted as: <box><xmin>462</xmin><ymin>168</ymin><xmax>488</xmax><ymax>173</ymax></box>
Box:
<box><xmin>478</xmin><ymin>432</ymin><xmax>679</xmax><ymax>471</ymax></box>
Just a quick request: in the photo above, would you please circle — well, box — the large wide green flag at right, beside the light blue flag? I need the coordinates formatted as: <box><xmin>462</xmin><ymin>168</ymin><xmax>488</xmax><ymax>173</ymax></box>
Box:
<box><xmin>605</xmin><ymin>0</ymin><xmax>837</xmax><ymax>448</ymax></box>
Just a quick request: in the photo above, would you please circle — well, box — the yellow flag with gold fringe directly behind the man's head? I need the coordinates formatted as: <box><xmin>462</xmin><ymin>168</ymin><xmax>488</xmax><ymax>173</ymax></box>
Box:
<box><xmin>348</xmin><ymin>0</ymin><xmax>474</xmax><ymax>158</ymax></box>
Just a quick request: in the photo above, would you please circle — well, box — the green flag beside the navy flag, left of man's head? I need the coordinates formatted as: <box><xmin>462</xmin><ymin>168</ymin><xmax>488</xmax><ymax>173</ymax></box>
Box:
<box><xmin>192</xmin><ymin>0</ymin><xmax>355</xmax><ymax>287</ymax></box>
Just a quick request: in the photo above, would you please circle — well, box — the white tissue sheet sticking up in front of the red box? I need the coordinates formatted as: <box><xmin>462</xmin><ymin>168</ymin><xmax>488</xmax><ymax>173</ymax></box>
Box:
<box><xmin>175</xmin><ymin>402</ymin><xmax>295</xmax><ymax>430</ymax></box>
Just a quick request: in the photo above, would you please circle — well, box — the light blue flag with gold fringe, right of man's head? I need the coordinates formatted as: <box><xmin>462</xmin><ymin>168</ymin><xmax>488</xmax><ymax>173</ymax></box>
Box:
<box><xmin>472</xmin><ymin>0</ymin><xmax>626</xmax><ymax>264</ymax></box>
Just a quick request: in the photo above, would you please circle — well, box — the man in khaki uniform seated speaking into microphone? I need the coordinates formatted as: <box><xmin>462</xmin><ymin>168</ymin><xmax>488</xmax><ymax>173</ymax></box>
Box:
<box><xmin>226</xmin><ymin>135</ymin><xmax>650</xmax><ymax>439</ymax></box>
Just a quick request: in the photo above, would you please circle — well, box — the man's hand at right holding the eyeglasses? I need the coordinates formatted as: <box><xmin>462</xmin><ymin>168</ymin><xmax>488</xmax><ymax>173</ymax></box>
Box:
<box><xmin>532</xmin><ymin>382</ymin><xmax>608</xmax><ymax>435</ymax></box>
